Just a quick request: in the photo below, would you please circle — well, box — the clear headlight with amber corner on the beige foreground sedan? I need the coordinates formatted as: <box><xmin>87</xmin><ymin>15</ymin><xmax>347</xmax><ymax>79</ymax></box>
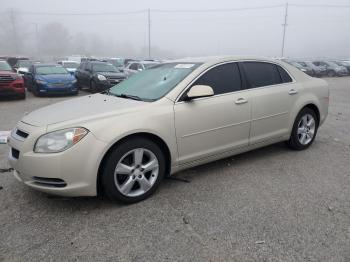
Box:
<box><xmin>34</xmin><ymin>127</ymin><xmax>89</xmax><ymax>153</ymax></box>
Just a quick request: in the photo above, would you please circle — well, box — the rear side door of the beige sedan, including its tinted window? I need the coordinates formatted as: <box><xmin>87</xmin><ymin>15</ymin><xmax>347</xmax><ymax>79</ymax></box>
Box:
<box><xmin>241</xmin><ymin>61</ymin><xmax>300</xmax><ymax>144</ymax></box>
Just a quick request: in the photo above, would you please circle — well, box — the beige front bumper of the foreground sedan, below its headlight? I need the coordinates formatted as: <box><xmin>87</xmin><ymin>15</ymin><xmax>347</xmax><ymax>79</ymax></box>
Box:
<box><xmin>8</xmin><ymin>122</ymin><xmax>106</xmax><ymax>197</ymax></box>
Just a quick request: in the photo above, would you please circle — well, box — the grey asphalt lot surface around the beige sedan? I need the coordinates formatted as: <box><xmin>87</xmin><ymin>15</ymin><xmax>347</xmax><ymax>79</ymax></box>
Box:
<box><xmin>0</xmin><ymin>77</ymin><xmax>350</xmax><ymax>261</ymax></box>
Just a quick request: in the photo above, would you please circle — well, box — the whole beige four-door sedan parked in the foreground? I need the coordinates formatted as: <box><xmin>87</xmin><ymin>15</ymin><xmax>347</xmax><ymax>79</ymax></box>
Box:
<box><xmin>9</xmin><ymin>57</ymin><xmax>329</xmax><ymax>203</ymax></box>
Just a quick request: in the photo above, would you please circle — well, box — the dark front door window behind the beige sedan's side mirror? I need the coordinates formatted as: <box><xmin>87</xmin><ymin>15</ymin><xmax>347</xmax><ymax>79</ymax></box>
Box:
<box><xmin>192</xmin><ymin>63</ymin><xmax>242</xmax><ymax>95</ymax></box>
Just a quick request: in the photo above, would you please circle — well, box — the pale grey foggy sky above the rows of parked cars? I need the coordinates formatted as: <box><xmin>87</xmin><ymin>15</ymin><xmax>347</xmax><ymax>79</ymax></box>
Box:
<box><xmin>0</xmin><ymin>0</ymin><xmax>350</xmax><ymax>59</ymax></box>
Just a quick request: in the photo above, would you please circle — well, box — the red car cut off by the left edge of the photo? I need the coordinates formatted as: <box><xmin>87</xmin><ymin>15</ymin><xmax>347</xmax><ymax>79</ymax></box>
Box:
<box><xmin>0</xmin><ymin>60</ymin><xmax>26</xmax><ymax>99</ymax></box>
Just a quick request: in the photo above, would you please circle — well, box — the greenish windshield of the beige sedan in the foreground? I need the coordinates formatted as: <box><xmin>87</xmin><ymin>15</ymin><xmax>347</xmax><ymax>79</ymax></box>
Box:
<box><xmin>110</xmin><ymin>63</ymin><xmax>200</xmax><ymax>101</ymax></box>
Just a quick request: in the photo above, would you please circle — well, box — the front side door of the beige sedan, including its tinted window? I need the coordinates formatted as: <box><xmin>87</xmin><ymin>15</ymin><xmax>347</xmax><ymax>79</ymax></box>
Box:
<box><xmin>174</xmin><ymin>63</ymin><xmax>250</xmax><ymax>164</ymax></box>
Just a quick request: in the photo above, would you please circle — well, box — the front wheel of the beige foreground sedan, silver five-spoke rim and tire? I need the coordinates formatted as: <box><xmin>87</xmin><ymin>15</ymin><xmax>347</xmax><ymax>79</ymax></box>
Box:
<box><xmin>101</xmin><ymin>138</ymin><xmax>165</xmax><ymax>204</ymax></box>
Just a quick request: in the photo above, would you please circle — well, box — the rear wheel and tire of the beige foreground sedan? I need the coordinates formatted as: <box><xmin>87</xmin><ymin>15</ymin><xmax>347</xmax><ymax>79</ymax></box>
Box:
<box><xmin>287</xmin><ymin>107</ymin><xmax>319</xmax><ymax>150</ymax></box>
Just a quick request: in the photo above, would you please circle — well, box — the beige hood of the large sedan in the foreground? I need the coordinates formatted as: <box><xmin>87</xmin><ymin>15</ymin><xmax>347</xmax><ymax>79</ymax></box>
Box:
<box><xmin>22</xmin><ymin>94</ymin><xmax>149</xmax><ymax>127</ymax></box>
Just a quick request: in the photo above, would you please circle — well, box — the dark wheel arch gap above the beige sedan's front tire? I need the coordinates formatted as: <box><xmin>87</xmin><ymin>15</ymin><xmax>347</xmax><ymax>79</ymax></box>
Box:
<box><xmin>96</xmin><ymin>132</ymin><xmax>171</xmax><ymax>195</ymax></box>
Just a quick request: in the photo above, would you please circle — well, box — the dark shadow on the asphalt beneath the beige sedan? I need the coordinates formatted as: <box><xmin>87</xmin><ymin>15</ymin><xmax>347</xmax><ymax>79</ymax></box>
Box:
<box><xmin>22</xmin><ymin>143</ymin><xmax>295</xmax><ymax>211</ymax></box>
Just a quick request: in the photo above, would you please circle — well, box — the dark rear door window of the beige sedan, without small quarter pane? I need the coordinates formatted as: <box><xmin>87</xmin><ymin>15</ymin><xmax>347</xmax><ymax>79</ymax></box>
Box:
<box><xmin>243</xmin><ymin>62</ymin><xmax>282</xmax><ymax>88</ymax></box>
